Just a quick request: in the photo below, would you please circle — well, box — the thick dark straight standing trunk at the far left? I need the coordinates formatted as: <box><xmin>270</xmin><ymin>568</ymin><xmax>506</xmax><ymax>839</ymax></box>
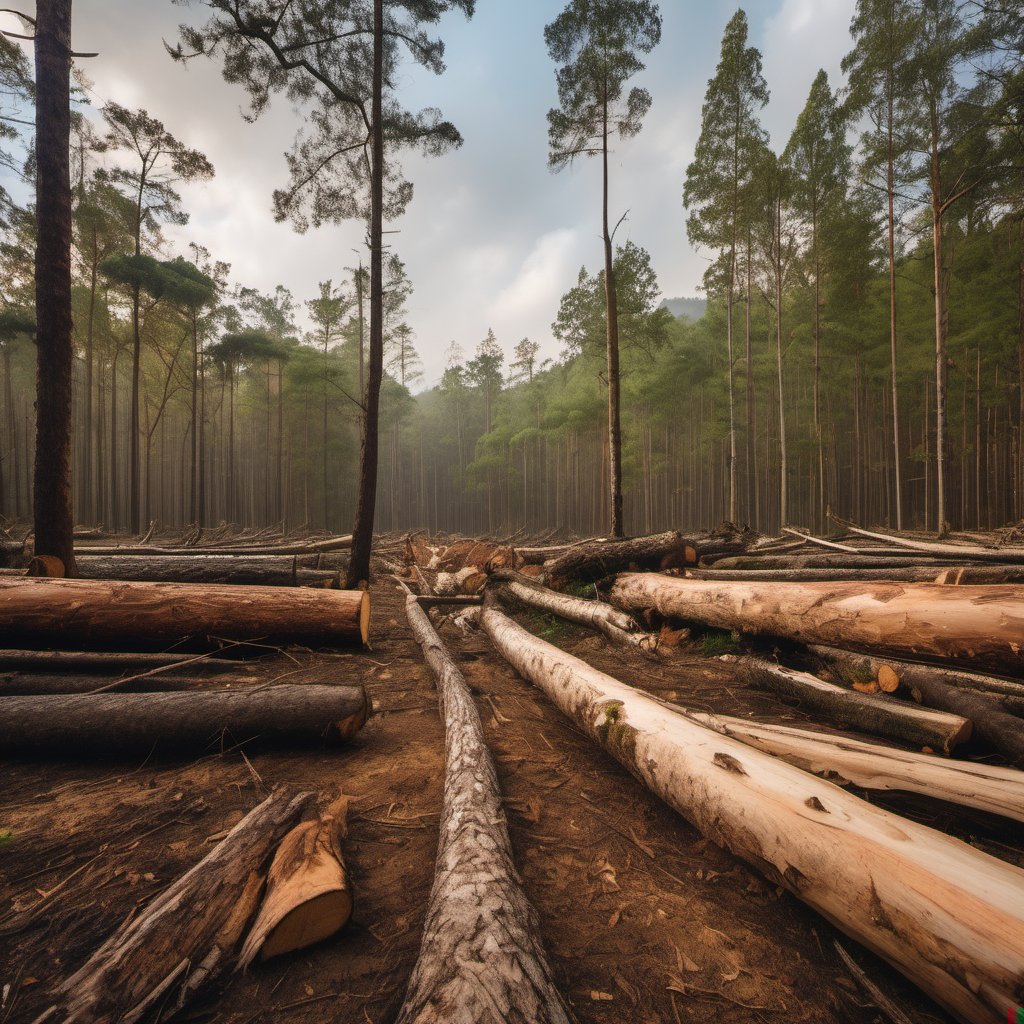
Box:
<box><xmin>33</xmin><ymin>0</ymin><xmax>76</xmax><ymax>575</ymax></box>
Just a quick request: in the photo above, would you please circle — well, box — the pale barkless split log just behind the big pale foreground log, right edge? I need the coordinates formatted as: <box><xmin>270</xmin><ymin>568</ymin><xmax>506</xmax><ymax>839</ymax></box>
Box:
<box><xmin>688</xmin><ymin>712</ymin><xmax>1024</xmax><ymax>821</ymax></box>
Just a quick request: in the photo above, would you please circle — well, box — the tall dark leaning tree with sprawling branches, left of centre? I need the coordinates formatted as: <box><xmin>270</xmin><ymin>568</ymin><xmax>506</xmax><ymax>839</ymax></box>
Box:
<box><xmin>171</xmin><ymin>0</ymin><xmax>475</xmax><ymax>587</ymax></box>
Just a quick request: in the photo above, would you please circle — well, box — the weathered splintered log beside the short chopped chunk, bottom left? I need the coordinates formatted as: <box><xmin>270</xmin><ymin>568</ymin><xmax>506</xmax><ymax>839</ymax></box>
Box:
<box><xmin>49</xmin><ymin>790</ymin><xmax>312</xmax><ymax>1024</ymax></box>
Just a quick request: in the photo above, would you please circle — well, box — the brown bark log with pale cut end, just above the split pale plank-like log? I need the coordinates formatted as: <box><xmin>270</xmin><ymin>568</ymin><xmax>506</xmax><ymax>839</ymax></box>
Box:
<box><xmin>738</xmin><ymin>657</ymin><xmax>971</xmax><ymax>754</ymax></box>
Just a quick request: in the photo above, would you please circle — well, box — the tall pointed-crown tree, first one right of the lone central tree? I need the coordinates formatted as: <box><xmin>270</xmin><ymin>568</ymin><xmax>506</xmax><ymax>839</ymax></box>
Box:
<box><xmin>683</xmin><ymin>10</ymin><xmax>768</xmax><ymax>522</ymax></box>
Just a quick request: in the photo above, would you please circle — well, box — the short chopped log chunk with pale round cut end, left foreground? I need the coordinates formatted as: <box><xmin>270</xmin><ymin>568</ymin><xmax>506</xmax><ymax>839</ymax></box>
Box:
<box><xmin>239</xmin><ymin>797</ymin><xmax>352</xmax><ymax>967</ymax></box>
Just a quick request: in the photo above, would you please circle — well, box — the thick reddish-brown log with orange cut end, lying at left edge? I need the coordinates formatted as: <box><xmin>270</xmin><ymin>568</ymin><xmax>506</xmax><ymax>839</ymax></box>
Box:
<box><xmin>0</xmin><ymin>579</ymin><xmax>370</xmax><ymax>647</ymax></box>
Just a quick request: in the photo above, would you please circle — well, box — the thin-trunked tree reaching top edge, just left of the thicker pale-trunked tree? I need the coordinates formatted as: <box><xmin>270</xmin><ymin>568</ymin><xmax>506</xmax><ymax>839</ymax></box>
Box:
<box><xmin>843</xmin><ymin>0</ymin><xmax>919</xmax><ymax>529</ymax></box>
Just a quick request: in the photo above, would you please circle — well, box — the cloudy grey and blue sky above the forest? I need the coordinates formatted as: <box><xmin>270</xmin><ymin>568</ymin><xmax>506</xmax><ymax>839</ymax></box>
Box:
<box><xmin>5</xmin><ymin>0</ymin><xmax>855</xmax><ymax>386</ymax></box>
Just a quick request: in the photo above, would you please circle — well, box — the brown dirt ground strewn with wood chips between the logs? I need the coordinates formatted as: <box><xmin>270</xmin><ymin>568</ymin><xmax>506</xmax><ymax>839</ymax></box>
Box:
<box><xmin>0</xmin><ymin>584</ymin><xmax>1024</xmax><ymax>1024</ymax></box>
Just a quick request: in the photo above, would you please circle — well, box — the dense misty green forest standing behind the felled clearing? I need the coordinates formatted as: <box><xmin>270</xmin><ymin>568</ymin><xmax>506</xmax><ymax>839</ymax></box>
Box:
<box><xmin>0</xmin><ymin>0</ymin><xmax>1024</xmax><ymax>534</ymax></box>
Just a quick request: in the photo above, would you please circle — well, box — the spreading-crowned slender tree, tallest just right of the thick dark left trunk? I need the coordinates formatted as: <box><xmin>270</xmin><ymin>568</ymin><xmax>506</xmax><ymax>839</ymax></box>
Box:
<box><xmin>103</xmin><ymin>103</ymin><xmax>213</xmax><ymax>534</ymax></box>
